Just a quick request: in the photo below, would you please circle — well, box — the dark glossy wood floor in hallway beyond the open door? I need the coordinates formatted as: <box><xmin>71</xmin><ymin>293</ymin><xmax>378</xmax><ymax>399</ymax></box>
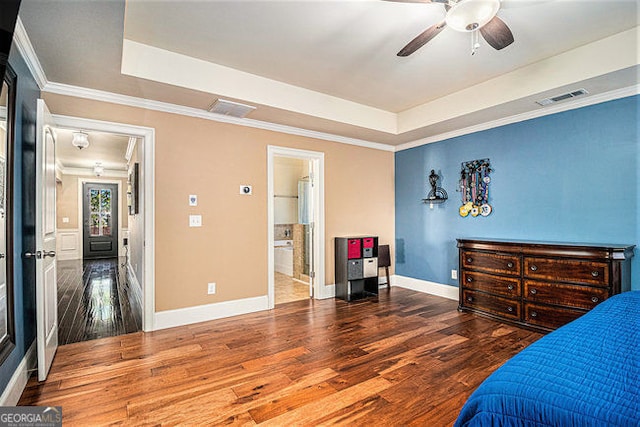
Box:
<box><xmin>58</xmin><ymin>258</ymin><xmax>142</xmax><ymax>345</ymax></box>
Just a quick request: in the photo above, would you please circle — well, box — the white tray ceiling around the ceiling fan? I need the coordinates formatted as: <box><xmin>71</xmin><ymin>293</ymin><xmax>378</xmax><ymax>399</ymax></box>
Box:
<box><xmin>20</xmin><ymin>0</ymin><xmax>640</xmax><ymax>145</ymax></box>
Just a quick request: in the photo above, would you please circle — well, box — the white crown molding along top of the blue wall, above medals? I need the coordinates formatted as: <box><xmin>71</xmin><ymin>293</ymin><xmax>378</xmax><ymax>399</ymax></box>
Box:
<box><xmin>394</xmin><ymin>84</ymin><xmax>640</xmax><ymax>152</ymax></box>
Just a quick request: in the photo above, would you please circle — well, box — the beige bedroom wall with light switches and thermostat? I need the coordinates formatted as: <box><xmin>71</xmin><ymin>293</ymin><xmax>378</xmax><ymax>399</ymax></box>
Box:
<box><xmin>44</xmin><ymin>93</ymin><xmax>394</xmax><ymax>311</ymax></box>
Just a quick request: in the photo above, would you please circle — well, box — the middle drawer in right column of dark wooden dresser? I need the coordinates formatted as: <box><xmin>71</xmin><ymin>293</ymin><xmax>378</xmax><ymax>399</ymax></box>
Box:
<box><xmin>524</xmin><ymin>280</ymin><xmax>609</xmax><ymax>310</ymax></box>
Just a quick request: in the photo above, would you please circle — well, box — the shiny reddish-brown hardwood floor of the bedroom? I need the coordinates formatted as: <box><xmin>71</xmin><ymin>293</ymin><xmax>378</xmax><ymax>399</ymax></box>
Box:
<box><xmin>19</xmin><ymin>288</ymin><xmax>541</xmax><ymax>426</ymax></box>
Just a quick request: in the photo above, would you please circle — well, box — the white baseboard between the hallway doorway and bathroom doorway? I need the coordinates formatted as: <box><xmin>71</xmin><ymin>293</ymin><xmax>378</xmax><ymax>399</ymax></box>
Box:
<box><xmin>153</xmin><ymin>295</ymin><xmax>269</xmax><ymax>331</ymax></box>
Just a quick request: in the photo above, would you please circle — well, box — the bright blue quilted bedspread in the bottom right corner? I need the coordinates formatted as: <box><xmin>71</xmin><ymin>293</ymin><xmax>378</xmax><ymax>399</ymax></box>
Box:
<box><xmin>455</xmin><ymin>291</ymin><xmax>640</xmax><ymax>427</ymax></box>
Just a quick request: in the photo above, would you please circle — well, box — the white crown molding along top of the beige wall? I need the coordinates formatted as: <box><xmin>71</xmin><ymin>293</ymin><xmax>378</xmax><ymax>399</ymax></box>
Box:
<box><xmin>43</xmin><ymin>82</ymin><xmax>394</xmax><ymax>151</ymax></box>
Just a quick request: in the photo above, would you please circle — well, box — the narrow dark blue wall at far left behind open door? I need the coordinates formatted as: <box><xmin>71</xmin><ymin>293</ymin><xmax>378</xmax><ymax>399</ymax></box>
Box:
<box><xmin>0</xmin><ymin>45</ymin><xmax>40</xmax><ymax>393</ymax></box>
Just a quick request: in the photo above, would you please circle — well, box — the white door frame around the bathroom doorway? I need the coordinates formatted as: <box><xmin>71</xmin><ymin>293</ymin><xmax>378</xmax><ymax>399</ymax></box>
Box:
<box><xmin>267</xmin><ymin>145</ymin><xmax>324</xmax><ymax>309</ymax></box>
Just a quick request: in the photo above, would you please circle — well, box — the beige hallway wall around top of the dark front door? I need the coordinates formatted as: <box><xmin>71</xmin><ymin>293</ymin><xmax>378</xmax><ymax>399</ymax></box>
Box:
<box><xmin>56</xmin><ymin>174</ymin><xmax>128</xmax><ymax>229</ymax></box>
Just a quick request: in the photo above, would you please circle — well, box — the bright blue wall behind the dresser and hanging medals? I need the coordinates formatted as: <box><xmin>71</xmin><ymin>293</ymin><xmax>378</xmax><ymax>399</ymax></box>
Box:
<box><xmin>395</xmin><ymin>96</ymin><xmax>640</xmax><ymax>289</ymax></box>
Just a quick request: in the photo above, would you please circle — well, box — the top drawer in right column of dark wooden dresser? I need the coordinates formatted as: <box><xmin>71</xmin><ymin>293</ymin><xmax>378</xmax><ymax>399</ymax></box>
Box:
<box><xmin>524</xmin><ymin>257</ymin><xmax>609</xmax><ymax>286</ymax></box>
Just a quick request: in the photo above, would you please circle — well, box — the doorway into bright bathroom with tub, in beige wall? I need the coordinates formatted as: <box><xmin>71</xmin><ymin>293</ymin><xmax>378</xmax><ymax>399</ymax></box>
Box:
<box><xmin>268</xmin><ymin>147</ymin><xmax>324</xmax><ymax>307</ymax></box>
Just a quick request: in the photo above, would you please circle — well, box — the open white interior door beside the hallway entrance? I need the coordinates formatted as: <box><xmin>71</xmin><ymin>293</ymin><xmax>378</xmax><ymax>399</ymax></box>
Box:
<box><xmin>34</xmin><ymin>99</ymin><xmax>58</xmax><ymax>381</ymax></box>
